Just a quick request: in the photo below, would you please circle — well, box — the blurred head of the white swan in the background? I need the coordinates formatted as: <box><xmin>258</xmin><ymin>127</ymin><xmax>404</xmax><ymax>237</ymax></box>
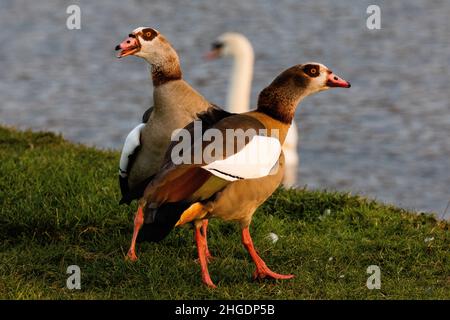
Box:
<box><xmin>205</xmin><ymin>32</ymin><xmax>253</xmax><ymax>60</ymax></box>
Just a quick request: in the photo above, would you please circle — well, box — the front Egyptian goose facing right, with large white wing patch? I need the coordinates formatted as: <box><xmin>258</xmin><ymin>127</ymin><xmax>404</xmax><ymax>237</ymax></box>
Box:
<box><xmin>127</xmin><ymin>63</ymin><xmax>350</xmax><ymax>288</ymax></box>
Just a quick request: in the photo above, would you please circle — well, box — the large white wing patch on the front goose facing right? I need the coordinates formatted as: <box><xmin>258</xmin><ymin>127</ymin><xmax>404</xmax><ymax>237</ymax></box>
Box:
<box><xmin>202</xmin><ymin>136</ymin><xmax>281</xmax><ymax>181</ymax></box>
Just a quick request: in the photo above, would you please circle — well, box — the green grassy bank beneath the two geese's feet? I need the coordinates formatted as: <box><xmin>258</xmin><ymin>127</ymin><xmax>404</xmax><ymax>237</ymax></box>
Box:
<box><xmin>0</xmin><ymin>127</ymin><xmax>450</xmax><ymax>299</ymax></box>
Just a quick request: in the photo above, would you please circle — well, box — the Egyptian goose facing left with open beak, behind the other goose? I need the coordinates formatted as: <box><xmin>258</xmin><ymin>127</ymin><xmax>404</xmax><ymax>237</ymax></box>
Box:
<box><xmin>115</xmin><ymin>27</ymin><xmax>226</xmax><ymax>260</ymax></box>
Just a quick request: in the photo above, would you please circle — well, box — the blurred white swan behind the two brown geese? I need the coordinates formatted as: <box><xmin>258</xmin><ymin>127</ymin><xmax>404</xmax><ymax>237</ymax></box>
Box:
<box><xmin>206</xmin><ymin>32</ymin><xmax>299</xmax><ymax>187</ymax></box>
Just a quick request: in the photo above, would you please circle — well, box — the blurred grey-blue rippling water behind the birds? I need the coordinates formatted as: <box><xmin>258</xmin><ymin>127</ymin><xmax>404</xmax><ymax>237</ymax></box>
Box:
<box><xmin>0</xmin><ymin>0</ymin><xmax>450</xmax><ymax>218</ymax></box>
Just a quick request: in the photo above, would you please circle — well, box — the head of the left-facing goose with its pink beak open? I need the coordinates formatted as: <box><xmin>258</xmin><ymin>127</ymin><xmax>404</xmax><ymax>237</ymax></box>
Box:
<box><xmin>116</xmin><ymin>27</ymin><xmax>176</xmax><ymax>64</ymax></box>
